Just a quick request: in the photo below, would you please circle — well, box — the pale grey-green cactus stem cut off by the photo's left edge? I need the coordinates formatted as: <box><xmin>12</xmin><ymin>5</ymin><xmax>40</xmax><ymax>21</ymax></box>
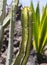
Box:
<box><xmin>0</xmin><ymin>0</ymin><xmax>6</xmax><ymax>51</ymax></box>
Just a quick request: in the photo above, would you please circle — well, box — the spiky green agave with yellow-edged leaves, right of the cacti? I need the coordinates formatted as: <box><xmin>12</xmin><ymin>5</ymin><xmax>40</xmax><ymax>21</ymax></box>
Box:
<box><xmin>30</xmin><ymin>3</ymin><xmax>47</xmax><ymax>54</ymax></box>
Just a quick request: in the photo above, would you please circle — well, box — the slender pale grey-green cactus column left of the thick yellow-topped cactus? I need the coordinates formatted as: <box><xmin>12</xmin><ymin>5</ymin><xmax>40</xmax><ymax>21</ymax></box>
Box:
<box><xmin>6</xmin><ymin>0</ymin><xmax>18</xmax><ymax>65</ymax></box>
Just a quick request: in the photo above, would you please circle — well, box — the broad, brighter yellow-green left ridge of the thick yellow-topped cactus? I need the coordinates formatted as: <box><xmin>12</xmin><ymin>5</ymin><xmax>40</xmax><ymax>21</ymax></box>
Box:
<box><xmin>14</xmin><ymin>8</ymin><xmax>28</xmax><ymax>65</ymax></box>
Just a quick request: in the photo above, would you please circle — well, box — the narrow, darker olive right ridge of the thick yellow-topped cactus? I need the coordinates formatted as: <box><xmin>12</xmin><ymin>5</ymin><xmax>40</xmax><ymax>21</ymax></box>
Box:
<box><xmin>21</xmin><ymin>8</ymin><xmax>32</xmax><ymax>65</ymax></box>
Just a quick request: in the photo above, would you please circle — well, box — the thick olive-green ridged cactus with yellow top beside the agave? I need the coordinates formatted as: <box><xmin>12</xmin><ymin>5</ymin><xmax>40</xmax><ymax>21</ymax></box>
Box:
<box><xmin>14</xmin><ymin>7</ymin><xmax>32</xmax><ymax>65</ymax></box>
